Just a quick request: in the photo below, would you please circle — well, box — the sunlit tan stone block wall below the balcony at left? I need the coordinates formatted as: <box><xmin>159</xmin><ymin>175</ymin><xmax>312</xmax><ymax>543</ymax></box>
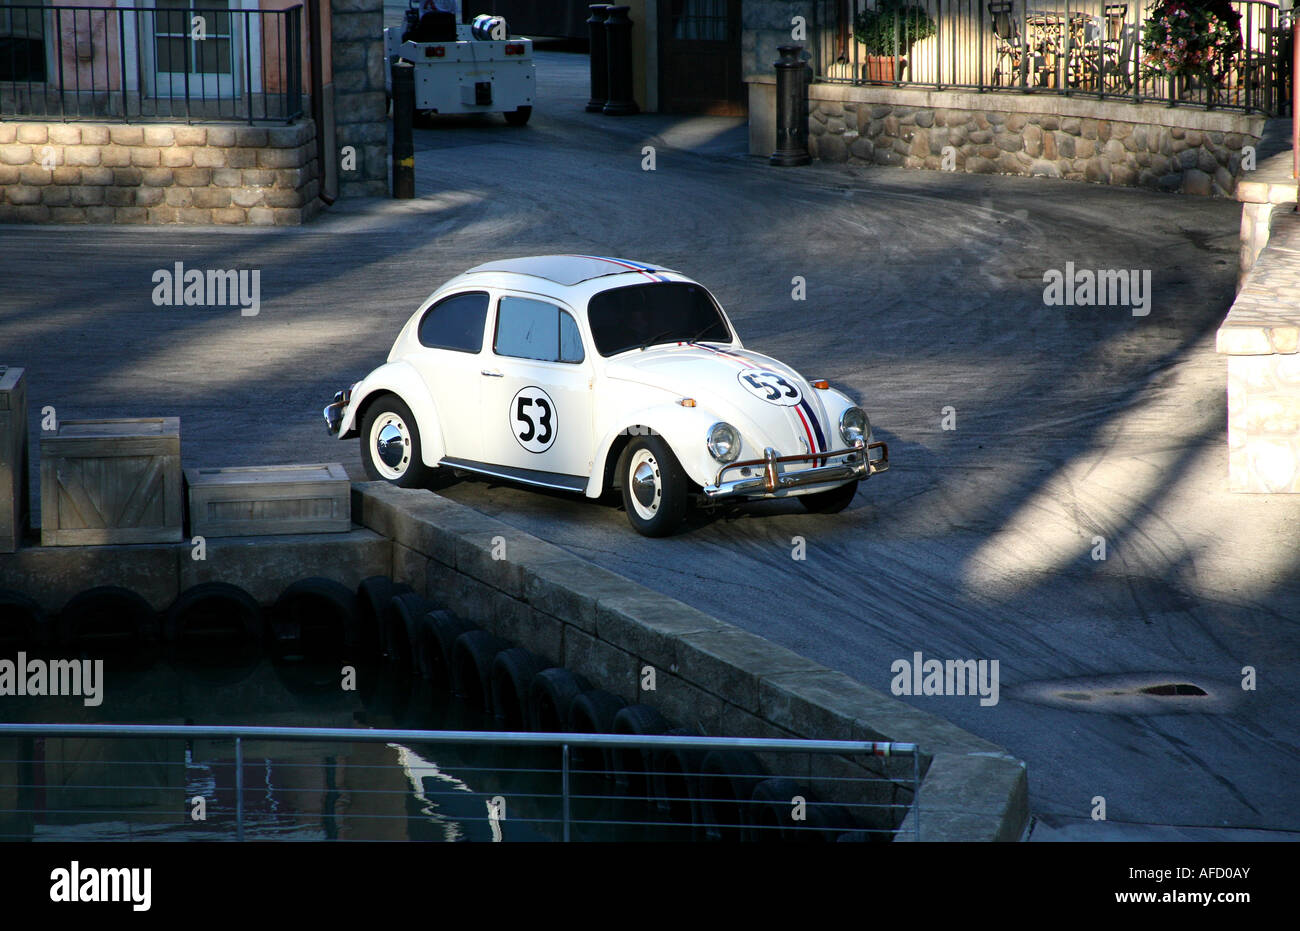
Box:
<box><xmin>0</xmin><ymin>120</ymin><xmax>320</xmax><ymax>226</ymax></box>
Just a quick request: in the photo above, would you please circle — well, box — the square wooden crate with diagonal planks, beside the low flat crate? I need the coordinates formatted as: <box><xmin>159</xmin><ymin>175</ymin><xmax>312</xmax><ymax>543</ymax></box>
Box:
<box><xmin>40</xmin><ymin>417</ymin><xmax>183</xmax><ymax>546</ymax></box>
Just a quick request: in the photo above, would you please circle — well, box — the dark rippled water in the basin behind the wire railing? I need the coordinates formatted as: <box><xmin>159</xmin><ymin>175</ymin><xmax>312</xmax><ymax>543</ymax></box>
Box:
<box><xmin>0</xmin><ymin>651</ymin><xmax>667</xmax><ymax>841</ymax></box>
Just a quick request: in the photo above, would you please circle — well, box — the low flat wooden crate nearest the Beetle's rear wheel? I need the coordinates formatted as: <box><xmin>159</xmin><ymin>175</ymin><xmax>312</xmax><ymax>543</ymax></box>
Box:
<box><xmin>185</xmin><ymin>463</ymin><xmax>352</xmax><ymax>537</ymax></box>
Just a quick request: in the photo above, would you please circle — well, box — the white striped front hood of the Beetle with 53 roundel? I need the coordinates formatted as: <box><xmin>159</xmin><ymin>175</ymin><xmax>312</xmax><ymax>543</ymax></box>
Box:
<box><xmin>606</xmin><ymin>343</ymin><xmax>842</xmax><ymax>464</ymax></box>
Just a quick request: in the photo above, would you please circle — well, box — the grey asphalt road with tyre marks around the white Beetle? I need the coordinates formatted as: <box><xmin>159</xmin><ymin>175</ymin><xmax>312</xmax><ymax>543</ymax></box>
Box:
<box><xmin>0</xmin><ymin>52</ymin><xmax>1300</xmax><ymax>839</ymax></box>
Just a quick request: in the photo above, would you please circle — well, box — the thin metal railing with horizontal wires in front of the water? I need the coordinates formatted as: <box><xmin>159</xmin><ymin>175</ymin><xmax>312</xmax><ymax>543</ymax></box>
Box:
<box><xmin>0</xmin><ymin>724</ymin><xmax>920</xmax><ymax>841</ymax></box>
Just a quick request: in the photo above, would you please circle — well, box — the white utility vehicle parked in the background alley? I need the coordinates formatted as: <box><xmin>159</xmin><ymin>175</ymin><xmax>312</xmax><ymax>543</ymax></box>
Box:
<box><xmin>384</xmin><ymin>0</ymin><xmax>537</xmax><ymax>126</ymax></box>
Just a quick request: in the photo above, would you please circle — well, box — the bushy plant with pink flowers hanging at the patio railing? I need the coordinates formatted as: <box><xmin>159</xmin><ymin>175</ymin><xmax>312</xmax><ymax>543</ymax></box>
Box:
<box><xmin>1141</xmin><ymin>0</ymin><xmax>1242</xmax><ymax>95</ymax></box>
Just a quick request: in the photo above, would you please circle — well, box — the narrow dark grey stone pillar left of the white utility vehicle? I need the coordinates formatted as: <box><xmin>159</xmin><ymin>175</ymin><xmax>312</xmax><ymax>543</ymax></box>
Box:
<box><xmin>330</xmin><ymin>0</ymin><xmax>389</xmax><ymax>198</ymax></box>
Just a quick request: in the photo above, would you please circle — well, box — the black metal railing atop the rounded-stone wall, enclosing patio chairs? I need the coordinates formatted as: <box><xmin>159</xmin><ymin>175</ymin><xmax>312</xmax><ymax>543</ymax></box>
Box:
<box><xmin>809</xmin><ymin>0</ymin><xmax>1292</xmax><ymax>116</ymax></box>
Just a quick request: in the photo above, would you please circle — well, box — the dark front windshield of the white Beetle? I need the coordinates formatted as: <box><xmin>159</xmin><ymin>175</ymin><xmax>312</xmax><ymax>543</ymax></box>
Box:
<box><xmin>586</xmin><ymin>281</ymin><xmax>732</xmax><ymax>356</ymax></box>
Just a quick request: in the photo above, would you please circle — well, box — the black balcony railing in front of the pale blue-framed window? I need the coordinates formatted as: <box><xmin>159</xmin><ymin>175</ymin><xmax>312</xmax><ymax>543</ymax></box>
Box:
<box><xmin>0</xmin><ymin>0</ymin><xmax>303</xmax><ymax>124</ymax></box>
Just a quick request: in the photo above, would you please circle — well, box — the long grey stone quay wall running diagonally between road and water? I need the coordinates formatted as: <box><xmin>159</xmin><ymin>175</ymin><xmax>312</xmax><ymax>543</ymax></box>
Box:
<box><xmin>352</xmin><ymin>482</ymin><xmax>1028</xmax><ymax>840</ymax></box>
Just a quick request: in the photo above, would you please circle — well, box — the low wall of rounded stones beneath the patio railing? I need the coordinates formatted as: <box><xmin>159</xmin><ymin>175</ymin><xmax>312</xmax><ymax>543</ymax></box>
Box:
<box><xmin>809</xmin><ymin>85</ymin><xmax>1262</xmax><ymax>196</ymax></box>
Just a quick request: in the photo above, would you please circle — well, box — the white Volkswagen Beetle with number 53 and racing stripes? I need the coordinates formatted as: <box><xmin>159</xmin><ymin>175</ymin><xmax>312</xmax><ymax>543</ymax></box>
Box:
<box><xmin>325</xmin><ymin>255</ymin><xmax>889</xmax><ymax>536</ymax></box>
